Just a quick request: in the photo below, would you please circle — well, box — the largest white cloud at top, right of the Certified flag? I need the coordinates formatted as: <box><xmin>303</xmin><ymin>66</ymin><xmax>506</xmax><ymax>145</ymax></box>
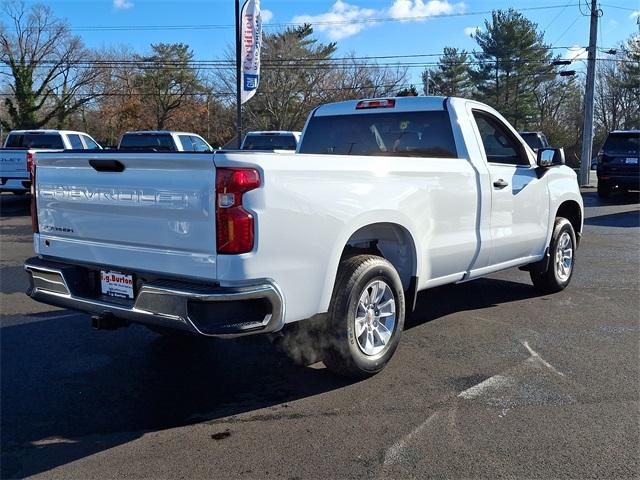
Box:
<box><xmin>292</xmin><ymin>0</ymin><xmax>465</xmax><ymax>40</ymax></box>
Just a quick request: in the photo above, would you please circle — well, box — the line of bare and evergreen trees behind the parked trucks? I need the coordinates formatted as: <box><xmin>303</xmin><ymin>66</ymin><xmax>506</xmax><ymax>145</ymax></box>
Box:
<box><xmin>0</xmin><ymin>1</ymin><xmax>640</xmax><ymax>158</ymax></box>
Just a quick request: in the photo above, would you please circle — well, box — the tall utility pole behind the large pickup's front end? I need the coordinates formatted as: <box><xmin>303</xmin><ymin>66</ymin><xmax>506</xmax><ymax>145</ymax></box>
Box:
<box><xmin>579</xmin><ymin>0</ymin><xmax>599</xmax><ymax>186</ymax></box>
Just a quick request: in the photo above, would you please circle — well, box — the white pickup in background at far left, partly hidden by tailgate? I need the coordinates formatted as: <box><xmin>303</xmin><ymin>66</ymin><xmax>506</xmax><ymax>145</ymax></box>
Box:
<box><xmin>0</xmin><ymin>130</ymin><xmax>101</xmax><ymax>194</ymax></box>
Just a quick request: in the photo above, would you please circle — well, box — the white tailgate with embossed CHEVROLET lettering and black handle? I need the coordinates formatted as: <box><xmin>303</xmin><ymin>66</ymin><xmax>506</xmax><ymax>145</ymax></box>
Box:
<box><xmin>34</xmin><ymin>153</ymin><xmax>216</xmax><ymax>280</ymax></box>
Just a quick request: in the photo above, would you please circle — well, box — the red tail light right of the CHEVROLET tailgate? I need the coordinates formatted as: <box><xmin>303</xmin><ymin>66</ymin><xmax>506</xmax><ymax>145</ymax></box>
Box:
<box><xmin>216</xmin><ymin>168</ymin><xmax>260</xmax><ymax>254</ymax></box>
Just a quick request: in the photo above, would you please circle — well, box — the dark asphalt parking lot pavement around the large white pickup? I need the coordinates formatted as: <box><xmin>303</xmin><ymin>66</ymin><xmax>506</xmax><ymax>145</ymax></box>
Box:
<box><xmin>0</xmin><ymin>189</ymin><xmax>640</xmax><ymax>479</ymax></box>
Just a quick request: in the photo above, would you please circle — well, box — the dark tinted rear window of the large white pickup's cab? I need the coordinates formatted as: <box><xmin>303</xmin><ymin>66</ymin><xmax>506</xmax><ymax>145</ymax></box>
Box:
<box><xmin>300</xmin><ymin>111</ymin><xmax>458</xmax><ymax>158</ymax></box>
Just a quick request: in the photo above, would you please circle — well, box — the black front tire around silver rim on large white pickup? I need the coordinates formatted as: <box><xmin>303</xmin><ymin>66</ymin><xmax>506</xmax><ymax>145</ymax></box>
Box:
<box><xmin>530</xmin><ymin>217</ymin><xmax>577</xmax><ymax>294</ymax></box>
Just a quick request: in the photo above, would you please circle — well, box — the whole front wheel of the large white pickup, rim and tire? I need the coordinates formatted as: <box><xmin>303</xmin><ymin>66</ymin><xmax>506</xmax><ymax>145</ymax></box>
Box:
<box><xmin>530</xmin><ymin>217</ymin><xmax>576</xmax><ymax>293</ymax></box>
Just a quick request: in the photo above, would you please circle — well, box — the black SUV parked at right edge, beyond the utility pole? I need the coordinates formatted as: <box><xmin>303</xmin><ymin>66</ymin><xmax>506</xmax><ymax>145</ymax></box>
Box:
<box><xmin>598</xmin><ymin>130</ymin><xmax>640</xmax><ymax>198</ymax></box>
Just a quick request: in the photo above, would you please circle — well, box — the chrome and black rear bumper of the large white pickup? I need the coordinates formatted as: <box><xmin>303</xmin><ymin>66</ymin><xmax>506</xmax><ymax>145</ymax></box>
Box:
<box><xmin>24</xmin><ymin>257</ymin><xmax>284</xmax><ymax>338</ymax></box>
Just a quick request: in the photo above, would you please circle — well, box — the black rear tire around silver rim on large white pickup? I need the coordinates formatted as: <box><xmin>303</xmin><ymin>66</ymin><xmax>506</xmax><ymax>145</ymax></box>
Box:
<box><xmin>323</xmin><ymin>255</ymin><xmax>405</xmax><ymax>378</ymax></box>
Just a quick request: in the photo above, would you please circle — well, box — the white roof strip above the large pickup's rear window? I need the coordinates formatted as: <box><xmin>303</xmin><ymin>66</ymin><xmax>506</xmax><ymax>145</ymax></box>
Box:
<box><xmin>314</xmin><ymin>96</ymin><xmax>448</xmax><ymax>116</ymax></box>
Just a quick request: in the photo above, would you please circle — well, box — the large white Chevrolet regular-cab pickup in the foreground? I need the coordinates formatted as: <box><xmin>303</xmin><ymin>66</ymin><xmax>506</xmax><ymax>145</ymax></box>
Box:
<box><xmin>25</xmin><ymin>97</ymin><xmax>583</xmax><ymax>376</ymax></box>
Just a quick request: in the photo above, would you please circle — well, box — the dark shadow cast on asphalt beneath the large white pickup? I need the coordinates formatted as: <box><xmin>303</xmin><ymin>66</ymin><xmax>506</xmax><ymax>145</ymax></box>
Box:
<box><xmin>0</xmin><ymin>279</ymin><xmax>536</xmax><ymax>478</ymax></box>
